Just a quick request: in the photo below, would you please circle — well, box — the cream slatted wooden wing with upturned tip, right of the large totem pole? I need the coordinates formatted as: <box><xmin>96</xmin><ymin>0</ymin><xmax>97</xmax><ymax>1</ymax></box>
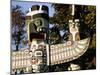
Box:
<box><xmin>47</xmin><ymin>38</ymin><xmax>90</xmax><ymax>65</ymax></box>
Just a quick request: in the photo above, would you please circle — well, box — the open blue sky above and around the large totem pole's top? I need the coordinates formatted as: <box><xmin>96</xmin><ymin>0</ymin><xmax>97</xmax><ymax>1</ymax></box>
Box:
<box><xmin>11</xmin><ymin>0</ymin><xmax>55</xmax><ymax>17</ymax></box>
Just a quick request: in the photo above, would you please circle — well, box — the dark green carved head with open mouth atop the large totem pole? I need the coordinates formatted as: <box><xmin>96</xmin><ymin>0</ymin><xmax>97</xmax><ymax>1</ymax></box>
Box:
<box><xmin>26</xmin><ymin>5</ymin><xmax>49</xmax><ymax>42</ymax></box>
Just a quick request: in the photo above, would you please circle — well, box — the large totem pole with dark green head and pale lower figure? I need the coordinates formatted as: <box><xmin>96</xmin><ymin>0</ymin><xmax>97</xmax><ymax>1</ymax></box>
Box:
<box><xmin>26</xmin><ymin>5</ymin><xmax>49</xmax><ymax>72</ymax></box>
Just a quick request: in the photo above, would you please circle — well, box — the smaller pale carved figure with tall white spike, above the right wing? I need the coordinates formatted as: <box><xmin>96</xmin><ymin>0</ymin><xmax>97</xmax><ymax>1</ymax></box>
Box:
<box><xmin>69</xmin><ymin>5</ymin><xmax>80</xmax><ymax>41</ymax></box>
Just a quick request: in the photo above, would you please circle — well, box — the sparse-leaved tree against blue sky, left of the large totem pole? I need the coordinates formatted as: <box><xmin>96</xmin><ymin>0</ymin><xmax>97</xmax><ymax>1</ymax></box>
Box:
<box><xmin>11</xmin><ymin>5</ymin><xmax>27</xmax><ymax>51</ymax></box>
